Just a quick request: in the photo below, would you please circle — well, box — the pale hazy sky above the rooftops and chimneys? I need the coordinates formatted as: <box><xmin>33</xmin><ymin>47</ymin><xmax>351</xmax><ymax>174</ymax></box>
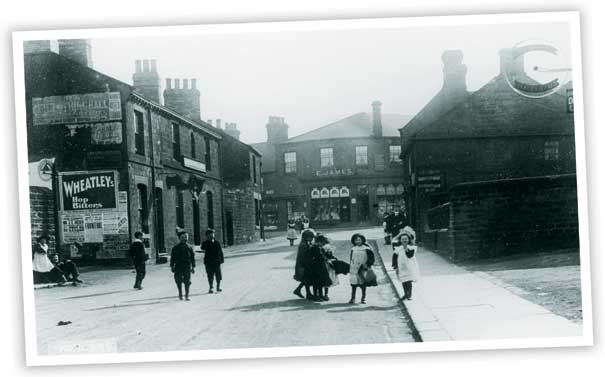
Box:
<box><xmin>92</xmin><ymin>23</ymin><xmax>571</xmax><ymax>143</ymax></box>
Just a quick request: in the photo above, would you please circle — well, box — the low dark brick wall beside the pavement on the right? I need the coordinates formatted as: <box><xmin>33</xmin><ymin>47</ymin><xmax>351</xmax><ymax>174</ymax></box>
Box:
<box><xmin>444</xmin><ymin>174</ymin><xmax>579</xmax><ymax>261</ymax></box>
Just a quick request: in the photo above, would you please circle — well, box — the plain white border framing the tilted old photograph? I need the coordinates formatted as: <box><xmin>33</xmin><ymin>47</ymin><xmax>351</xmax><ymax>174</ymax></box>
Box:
<box><xmin>13</xmin><ymin>11</ymin><xmax>594</xmax><ymax>366</ymax></box>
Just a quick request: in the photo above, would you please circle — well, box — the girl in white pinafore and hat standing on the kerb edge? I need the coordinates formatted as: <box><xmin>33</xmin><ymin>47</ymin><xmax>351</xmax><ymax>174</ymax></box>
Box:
<box><xmin>392</xmin><ymin>232</ymin><xmax>420</xmax><ymax>300</ymax></box>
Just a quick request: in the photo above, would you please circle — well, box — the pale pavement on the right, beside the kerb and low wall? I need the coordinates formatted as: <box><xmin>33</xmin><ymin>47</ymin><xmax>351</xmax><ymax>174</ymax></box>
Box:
<box><xmin>371</xmin><ymin>226</ymin><xmax>582</xmax><ymax>342</ymax></box>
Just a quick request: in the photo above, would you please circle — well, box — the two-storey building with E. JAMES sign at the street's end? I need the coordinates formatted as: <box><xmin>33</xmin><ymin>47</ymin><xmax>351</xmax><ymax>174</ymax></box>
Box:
<box><xmin>253</xmin><ymin>101</ymin><xmax>409</xmax><ymax>229</ymax></box>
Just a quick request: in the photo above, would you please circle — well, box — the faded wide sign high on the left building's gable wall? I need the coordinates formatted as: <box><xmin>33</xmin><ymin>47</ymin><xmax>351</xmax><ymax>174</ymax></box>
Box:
<box><xmin>32</xmin><ymin>92</ymin><xmax>122</xmax><ymax>126</ymax></box>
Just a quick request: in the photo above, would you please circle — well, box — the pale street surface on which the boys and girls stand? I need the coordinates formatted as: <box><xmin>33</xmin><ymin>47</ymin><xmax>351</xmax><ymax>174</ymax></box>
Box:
<box><xmin>35</xmin><ymin>236</ymin><xmax>414</xmax><ymax>355</ymax></box>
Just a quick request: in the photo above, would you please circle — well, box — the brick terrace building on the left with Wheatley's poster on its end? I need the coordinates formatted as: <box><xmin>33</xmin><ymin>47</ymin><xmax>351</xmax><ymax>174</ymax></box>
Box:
<box><xmin>24</xmin><ymin>44</ymin><xmax>223</xmax><ymax>261</ymax></box>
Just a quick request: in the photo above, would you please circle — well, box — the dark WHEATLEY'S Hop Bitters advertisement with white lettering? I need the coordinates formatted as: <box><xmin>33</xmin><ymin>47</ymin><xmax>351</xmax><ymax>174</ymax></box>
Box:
<box><xmin>59</xmin><ymin>171</ymin><xmax>118</xmax><ymax>211</ymax></box>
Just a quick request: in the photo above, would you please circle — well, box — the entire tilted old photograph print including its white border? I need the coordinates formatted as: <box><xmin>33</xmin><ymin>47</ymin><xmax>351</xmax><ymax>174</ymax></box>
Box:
<box><xmin>14</xmin><ymin>12</ymin><xmax>592</xmax><ymax>365</ymax></box>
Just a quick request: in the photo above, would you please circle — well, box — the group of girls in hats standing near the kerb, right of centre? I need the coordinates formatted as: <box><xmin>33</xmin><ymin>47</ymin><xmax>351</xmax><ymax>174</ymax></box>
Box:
<box><xmin>293</xmin><ymin>227</ymin><xmax>420</xmax><ymax>304</ymax></box>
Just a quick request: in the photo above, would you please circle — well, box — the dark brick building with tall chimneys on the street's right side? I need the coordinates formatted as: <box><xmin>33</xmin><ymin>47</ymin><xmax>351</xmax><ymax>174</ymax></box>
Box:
<box><xmin>400</xmin><ymin>49</ymin><xmax>578</xmax><ymax>260</ymax></box>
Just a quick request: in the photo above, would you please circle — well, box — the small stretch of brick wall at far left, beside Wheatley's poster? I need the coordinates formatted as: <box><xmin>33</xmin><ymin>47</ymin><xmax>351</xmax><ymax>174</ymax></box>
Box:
<box><xmin>25</xmin><ymin>187</ymin><xmax>55</xmax><ymax>253</ymax></box>
